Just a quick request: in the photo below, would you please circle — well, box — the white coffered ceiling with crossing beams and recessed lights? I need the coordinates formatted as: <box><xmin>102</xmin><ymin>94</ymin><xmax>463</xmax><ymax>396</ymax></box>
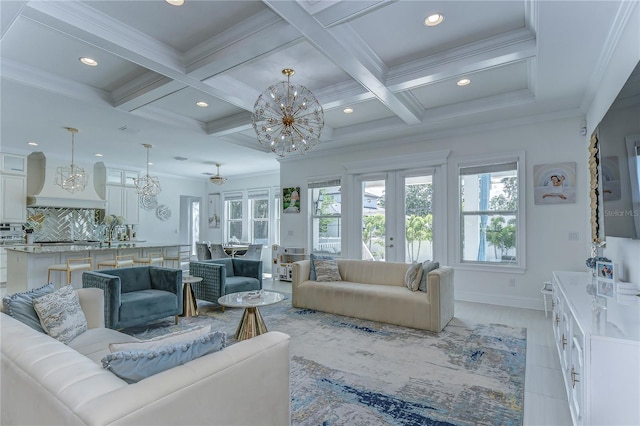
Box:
<box><xmin>0</xmin><ymin>0</ymin><xmax>637</xmax><ymax>179</ymax></box>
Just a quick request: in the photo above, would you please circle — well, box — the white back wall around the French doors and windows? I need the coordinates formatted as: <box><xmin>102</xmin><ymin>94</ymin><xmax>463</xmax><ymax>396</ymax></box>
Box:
<box><xmin>280</xmin><ymin>117</ymin><xmax>590</xmax><ymax>309</ymax></box>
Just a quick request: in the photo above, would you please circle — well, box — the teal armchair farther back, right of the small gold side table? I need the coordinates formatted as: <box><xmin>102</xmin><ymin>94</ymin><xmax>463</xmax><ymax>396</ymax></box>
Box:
<box><xmin>189</xmin><ymin>257</ymin><xmax>262</xmax><ymax>304</ymax></box>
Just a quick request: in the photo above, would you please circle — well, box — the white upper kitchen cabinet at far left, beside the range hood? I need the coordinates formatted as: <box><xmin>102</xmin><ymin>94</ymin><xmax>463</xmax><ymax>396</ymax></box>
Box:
<box><xmin>0</xmin><ymin>154</ymin><xmax>27</xmax><ymax>223</ymax></box>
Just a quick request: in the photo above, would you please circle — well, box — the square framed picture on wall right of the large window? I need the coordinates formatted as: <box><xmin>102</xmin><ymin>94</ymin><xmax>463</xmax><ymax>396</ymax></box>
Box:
<box><xmin>533</xmin><ymin>162</ymin><xmax>576</xmax><ymax>204</ymax></box>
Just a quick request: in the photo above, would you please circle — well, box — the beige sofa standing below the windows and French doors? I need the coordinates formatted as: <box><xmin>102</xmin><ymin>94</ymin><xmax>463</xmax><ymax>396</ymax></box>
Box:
<box><xmin>292</xmin><ymin>259</ymin><xmax>454</xmax><ymax>332</ymax></box>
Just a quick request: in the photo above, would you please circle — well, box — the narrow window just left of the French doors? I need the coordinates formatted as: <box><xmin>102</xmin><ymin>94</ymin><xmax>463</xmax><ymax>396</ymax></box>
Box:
<box><xmin>308</xmin><ymin>179</ymin><xmax>342</xmax><ymax>255</ymax></box>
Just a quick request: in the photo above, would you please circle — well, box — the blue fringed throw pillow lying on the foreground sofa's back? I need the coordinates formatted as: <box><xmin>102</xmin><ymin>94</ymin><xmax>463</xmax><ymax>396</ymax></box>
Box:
<box><xmin>101</xmin><ymin>331</ymin><xmax>227</xmax><ymax>383</ymax></box>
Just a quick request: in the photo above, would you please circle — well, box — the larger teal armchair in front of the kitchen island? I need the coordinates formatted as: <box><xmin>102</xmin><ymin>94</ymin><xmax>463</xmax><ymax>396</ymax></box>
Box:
<box><xmin>82</xmin><ymin>266</ymin><xmax>182</xmax><ymax>329</ymax></box>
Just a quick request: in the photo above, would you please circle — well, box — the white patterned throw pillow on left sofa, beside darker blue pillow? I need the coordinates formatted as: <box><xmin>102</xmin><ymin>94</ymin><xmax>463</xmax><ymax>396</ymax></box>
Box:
<box><xmin>33</xmin><ymin>285</ymin><xmax>87</xmax><ymax>344</ymax></box>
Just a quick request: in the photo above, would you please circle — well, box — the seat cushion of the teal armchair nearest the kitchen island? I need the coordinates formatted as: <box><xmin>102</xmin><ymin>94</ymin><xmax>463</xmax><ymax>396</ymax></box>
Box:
<box><xmin>118</xmin><ymin>290</ymin><xmax>178</xmax><ymax>324</ymax></box>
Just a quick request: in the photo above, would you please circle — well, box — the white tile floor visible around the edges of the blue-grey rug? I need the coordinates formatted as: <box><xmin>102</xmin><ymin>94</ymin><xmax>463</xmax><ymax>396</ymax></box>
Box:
<box><xmin>264</xmin><ymin>278</ymin><xmax>572</xmax><ymax>426</ymax></box>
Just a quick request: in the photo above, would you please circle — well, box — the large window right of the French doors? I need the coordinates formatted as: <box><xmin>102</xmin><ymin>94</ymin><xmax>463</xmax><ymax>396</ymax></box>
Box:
<box><xmin>459</xmin><ymin>161</ymin><xmax>524</xmax><ymax>266</ymax></box>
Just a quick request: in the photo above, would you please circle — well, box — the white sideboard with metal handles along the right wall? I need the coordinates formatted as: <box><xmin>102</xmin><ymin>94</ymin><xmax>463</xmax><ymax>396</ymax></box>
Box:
<box><xmin>552</xmin><ymin>271</ymin><xmax>640</xmax><ymax>425</ymax></box>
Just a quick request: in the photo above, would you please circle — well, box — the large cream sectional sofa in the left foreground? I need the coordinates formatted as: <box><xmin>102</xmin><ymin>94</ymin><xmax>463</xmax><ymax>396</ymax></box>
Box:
<box><xmin>0</xmin><ymin>288</ymin><xmax>290</xmax><ymax>425</ymax></box>
